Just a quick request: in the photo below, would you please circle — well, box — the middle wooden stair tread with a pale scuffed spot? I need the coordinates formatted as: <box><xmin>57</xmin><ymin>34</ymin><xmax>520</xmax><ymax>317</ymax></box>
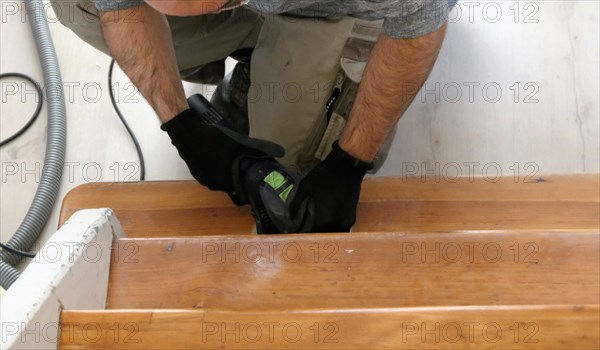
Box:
<box><xmin>107</xmin><ymin>231</ymin><xmax>600</xmax><ymax>310</ymax></box>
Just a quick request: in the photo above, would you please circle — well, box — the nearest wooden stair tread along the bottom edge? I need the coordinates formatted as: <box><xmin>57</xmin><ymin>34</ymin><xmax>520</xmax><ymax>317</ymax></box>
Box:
<box><xmin>60</xmin><ymin>305</ymin><xmax>600</xmax><ymax>350</ymax></box>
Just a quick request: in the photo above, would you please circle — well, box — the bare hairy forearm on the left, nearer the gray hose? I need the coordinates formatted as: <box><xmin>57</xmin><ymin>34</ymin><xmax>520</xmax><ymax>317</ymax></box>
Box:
<box><xmin>100</xmin><ymin>4</ymin><xmax>188</xmax><ymax>123</ymax></box>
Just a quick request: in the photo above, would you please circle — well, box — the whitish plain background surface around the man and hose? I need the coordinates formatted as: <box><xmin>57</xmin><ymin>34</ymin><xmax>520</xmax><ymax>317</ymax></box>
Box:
<box><xmin>0</xmin><ymin>0</ymin><xmax>600</xmax><ymax>254</ymax></box>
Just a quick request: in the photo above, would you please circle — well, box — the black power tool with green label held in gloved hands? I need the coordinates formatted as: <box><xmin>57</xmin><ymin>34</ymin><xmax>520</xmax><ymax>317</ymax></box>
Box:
<box><xmin>188</xmin><ymin>94</ymin><xmax>312</xmax><ymax>234</ymax></box>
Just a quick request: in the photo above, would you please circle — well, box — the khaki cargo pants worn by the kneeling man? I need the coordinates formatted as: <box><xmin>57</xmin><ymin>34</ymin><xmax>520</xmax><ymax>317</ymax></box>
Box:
<box><xmin>51</xmin><ymin>0</ymin><xmax>394</xmax><ymax>171</ymax></box>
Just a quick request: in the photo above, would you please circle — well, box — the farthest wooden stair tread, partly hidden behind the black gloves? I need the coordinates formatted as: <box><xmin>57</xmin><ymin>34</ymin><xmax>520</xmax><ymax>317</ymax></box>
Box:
<box><xmin>59</xmin><ymin>174</ymin><xmax>600</xmax><ymax>237</ymax></box>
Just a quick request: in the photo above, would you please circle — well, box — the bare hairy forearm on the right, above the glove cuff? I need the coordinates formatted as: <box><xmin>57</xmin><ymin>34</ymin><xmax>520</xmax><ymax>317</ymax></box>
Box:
<box><xmin>340</xmin><ymin>25</ymin><xmax>446</xmax><ymax>162</ymax></box>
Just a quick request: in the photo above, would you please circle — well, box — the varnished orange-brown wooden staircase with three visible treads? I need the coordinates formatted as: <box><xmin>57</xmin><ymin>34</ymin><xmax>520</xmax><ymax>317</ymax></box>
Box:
<box><xmin>60</xmin><ymin>174</ymin><xmax>600</xmax><ymax>349</ymax></box>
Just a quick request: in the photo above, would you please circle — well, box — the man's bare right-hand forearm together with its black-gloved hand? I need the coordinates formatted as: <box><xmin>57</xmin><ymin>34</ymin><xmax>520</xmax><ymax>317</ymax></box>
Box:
<box><xmin>290</xmin><ymin>25</ymin><xmax>446</xmax><ymax>232</ymax></box>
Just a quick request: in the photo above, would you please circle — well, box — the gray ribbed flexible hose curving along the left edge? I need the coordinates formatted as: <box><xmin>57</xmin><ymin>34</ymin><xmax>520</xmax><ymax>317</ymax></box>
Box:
<box><xmin>0</xmin><ymin>0</ymin><xmax>67</xmax><ymax>289</ymax></box>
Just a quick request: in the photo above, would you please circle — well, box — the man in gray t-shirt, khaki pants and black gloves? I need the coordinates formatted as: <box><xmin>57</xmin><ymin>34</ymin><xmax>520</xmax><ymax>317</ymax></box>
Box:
<box><xmin>52</xmin><ymin>0</ymin><xmax>456</xmax><ymax>232</ymax></box>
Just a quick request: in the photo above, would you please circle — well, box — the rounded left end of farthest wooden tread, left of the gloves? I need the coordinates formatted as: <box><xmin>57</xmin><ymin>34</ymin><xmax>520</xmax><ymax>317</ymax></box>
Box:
<box><xmin>59</xmin><ymin>181</ymin><xmax>254</xmax><ymax>237</ymax></box>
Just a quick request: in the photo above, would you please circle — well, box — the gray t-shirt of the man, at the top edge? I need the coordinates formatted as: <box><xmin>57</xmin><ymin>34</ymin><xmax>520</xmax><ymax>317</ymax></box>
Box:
<box><xmin>94</xmin><ymin>0</ymin><xmax>458</xmax><ymax>38</ymax></box>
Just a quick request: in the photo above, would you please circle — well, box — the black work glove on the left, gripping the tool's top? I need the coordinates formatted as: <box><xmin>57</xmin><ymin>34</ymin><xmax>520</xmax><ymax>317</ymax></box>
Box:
<box><xmin>161</xmin><ymin>109</ymin><xmax>285</xmax><ymax>205</ymax></box>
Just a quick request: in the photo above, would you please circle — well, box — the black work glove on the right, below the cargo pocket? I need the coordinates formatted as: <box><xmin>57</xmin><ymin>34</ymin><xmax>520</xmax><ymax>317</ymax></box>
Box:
<box><xmin>288</xmin><ymin>142</ymin><xmax>373</xmax><ymax>232</ymax></box>
